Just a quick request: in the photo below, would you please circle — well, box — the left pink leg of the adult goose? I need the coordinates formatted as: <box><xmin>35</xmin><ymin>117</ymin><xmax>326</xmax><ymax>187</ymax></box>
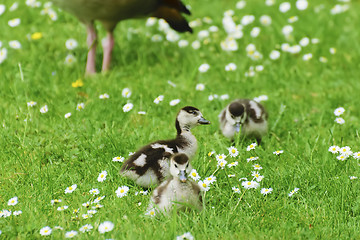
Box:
<box><xmin>85</xmin><ymin>22</ymin><xmax>97</xmax><ymax>75</ymax></box>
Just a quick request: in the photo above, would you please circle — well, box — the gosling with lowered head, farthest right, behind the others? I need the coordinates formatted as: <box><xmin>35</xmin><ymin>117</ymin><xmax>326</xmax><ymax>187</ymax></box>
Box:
<box><xmin>219</xmin><ymin>99</ymin><xmax>268</xmax><ymax>144</ymax></box>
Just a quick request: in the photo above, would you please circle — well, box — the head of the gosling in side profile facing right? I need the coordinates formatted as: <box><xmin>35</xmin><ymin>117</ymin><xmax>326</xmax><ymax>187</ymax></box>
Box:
<box><xmin>176</xmin><ymin>106</ymin><xmax>210</xmax><ymax>131</ymax></box>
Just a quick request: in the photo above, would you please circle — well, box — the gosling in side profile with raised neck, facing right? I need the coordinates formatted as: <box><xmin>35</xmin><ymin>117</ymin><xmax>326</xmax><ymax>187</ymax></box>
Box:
<box><xmin>120</xmin><ymin>106</ymin><xmax>210</xmax><ymax>188</ymax></box>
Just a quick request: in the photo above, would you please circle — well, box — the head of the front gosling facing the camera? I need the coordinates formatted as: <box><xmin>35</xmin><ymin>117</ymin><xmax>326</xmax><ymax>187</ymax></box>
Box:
<box><xmin>170</xmin><ymin>153</ymin><xmax>191</xmax><ymax>183</ymax></box>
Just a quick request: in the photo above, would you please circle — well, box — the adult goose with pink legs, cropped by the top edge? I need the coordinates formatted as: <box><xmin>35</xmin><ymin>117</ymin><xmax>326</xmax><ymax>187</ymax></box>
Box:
<box><xmin>52</xmin><ymin>0</ymin><xmax>192</xmax><ymax>75</ymax></box>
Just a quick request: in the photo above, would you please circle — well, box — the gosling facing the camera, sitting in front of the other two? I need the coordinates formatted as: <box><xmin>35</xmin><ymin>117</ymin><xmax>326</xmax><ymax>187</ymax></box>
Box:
<box><xmin>148</xmin><ymin>153</ymin><xmax>202</xmax><ymax>214</ymax></box>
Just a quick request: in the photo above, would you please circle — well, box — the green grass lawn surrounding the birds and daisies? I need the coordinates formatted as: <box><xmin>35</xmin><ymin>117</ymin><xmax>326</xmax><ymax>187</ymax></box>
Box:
<box><xmin>0</xmin><ymin>0</ymin><xmax>360</xmax><ymax>239</ymax></box>
